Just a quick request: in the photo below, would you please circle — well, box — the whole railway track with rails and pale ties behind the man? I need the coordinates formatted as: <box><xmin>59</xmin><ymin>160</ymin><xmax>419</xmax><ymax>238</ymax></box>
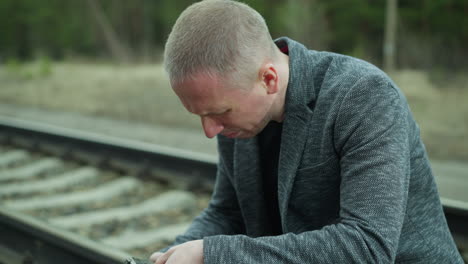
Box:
<box><xmin>0</xmin><ymin>118</ymin><xmax>468</xmax><ymax>264</ymax></box>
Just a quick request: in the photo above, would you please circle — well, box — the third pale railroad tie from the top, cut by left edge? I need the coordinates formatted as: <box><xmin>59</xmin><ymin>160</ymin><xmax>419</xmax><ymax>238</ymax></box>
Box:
<box><xmin>0</xmin><ymin>167</ymin><xmax>99</xmax><ymax>196</ymax></box>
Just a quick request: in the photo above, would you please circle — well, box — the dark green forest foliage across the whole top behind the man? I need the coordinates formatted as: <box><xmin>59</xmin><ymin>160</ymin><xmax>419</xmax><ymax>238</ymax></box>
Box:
<box><xmin>0</xmin><ymin>0</ymin><xmax>468</xmax><ymax>69</ymax></box>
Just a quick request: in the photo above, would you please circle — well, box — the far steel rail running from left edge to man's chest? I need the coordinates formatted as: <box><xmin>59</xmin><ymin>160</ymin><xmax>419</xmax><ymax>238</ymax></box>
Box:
<box><xmin>0</xmin><ymin>116</ymin><xmax>217</xmax><ymax>182</ymax></box>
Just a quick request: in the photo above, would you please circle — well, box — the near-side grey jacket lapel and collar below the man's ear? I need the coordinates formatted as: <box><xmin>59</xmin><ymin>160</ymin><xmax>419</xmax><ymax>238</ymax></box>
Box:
<box><xmin>278</xmin><ymin>38</ymin><xmax>315</xmax><ymax>233</ymax></box>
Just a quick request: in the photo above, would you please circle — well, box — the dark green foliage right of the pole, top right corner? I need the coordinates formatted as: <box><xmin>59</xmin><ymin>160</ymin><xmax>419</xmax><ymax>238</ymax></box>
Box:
<box><xmin>399</xmin><ymin>0</ymin><xmax>468</xmax><ymax>70</ymax></box>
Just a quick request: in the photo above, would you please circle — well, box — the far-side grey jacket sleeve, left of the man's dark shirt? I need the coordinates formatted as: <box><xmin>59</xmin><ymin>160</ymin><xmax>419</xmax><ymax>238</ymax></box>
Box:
<box><xmin>161</xmin><ymin>136</ymin><xmax>245</xmax><ymax>252</ymax></box>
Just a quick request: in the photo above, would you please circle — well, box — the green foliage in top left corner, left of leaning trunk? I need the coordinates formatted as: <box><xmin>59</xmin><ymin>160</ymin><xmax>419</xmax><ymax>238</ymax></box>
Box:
<box><xmin>0</xmin><ymin>0</ymin><xmax>96</xmax><ymax>59</ymax></box>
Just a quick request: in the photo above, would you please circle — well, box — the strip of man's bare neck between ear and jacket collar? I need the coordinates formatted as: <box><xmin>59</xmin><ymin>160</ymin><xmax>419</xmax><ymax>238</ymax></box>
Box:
<box><xmin>272</xmin><ymin>52</ymin><xmax>289</xmax><ymax>122</ymax></box>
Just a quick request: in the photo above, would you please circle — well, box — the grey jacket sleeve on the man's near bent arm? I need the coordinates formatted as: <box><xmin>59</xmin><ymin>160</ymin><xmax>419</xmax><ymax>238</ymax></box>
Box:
<box><xmin>204</xmin><ymin>77</ymin><xmax>410</xmax><ymax>264</ymax></box>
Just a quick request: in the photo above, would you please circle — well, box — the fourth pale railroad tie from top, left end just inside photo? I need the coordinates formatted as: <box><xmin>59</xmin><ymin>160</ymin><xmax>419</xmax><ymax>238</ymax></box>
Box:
<box><xmin>4</xmin><ymin>177</ymin><xmax>142</xmax><ymax>210</ymax></box>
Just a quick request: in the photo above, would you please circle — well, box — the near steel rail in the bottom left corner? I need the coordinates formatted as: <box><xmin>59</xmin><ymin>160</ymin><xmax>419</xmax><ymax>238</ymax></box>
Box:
<box><xmin>0</xmin><ymin>207</ymin><xmax>128</xmax><ymax>264</ymax></box>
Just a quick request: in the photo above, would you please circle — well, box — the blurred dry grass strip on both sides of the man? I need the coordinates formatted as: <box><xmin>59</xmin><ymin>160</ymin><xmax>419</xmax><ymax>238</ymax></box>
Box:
<box><xmin>0</xmin><ymin>63</ymin><xmax>468</xmax><ymax>161</ymax></box>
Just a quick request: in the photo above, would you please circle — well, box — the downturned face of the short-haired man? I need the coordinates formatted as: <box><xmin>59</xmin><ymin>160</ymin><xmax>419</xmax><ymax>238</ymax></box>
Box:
<box><xmin>172</xmin><ymin>74</ymin><xmax>274</xmax><ymax>138</ymax></box>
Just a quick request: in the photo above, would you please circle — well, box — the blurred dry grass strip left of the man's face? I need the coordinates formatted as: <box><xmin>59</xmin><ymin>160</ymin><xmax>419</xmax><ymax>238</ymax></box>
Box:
<box><xmin>0</xmin><ymin>63</ymin><xmax>200</xmax><ymax>128</ymax></box>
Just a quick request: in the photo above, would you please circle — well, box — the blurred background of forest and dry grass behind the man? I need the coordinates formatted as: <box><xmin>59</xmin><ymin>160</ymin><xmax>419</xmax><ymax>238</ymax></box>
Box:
<box><xmin>0</xmin><ymin>0</ymin><xmax>468</xmax><ymax>161</ymax></box>
